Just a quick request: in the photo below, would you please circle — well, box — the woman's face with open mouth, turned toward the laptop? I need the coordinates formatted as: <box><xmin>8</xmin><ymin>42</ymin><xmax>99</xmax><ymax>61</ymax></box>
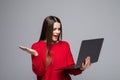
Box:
<box><xmin>52</xmin><ymin>22</ymin><xmax>61</xmax><ymax>43</ymax></box>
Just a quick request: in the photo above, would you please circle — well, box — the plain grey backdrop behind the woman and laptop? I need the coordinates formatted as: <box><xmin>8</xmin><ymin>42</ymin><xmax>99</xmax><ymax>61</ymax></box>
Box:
<box><xmin>0</xmin><ymin>0</ymin><xmax>120</xmax><ymax>80</ymax></box>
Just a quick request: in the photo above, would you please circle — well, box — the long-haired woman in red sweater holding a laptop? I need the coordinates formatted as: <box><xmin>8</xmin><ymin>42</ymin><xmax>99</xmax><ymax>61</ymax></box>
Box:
<box><xmin>20</xmin><ymin>16</ymin><xmax>90</xmax><ymax>80</ymax></box>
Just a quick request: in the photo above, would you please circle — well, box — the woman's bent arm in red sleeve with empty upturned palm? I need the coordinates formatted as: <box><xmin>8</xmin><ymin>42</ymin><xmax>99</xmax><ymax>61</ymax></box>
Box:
<box><xmin>19</xmin><ymin>45</ymin><xmax>45</xmax><ymax>76</ymax></box>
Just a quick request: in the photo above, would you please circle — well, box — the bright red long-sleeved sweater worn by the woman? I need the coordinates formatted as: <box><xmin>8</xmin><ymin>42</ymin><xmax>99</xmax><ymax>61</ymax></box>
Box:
<box><xmin>32</xmin><ymin>41</ymin><xmax>82</xmax><ymax>80</ymax></box>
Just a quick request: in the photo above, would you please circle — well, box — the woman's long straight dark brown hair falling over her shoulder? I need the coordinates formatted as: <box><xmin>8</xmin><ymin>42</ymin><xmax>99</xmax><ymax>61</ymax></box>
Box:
<box><xmin>39</xmin><ymin>16</ymin><xmax>62</xmax><ymax>55</ymax></box>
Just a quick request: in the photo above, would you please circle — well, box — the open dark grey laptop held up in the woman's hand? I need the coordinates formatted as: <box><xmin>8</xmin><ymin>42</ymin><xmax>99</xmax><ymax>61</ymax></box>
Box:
<box><xmin>57</xmin><ymin>38</ymin><xmax>104</xmax><ymax>69</ymax></box>
